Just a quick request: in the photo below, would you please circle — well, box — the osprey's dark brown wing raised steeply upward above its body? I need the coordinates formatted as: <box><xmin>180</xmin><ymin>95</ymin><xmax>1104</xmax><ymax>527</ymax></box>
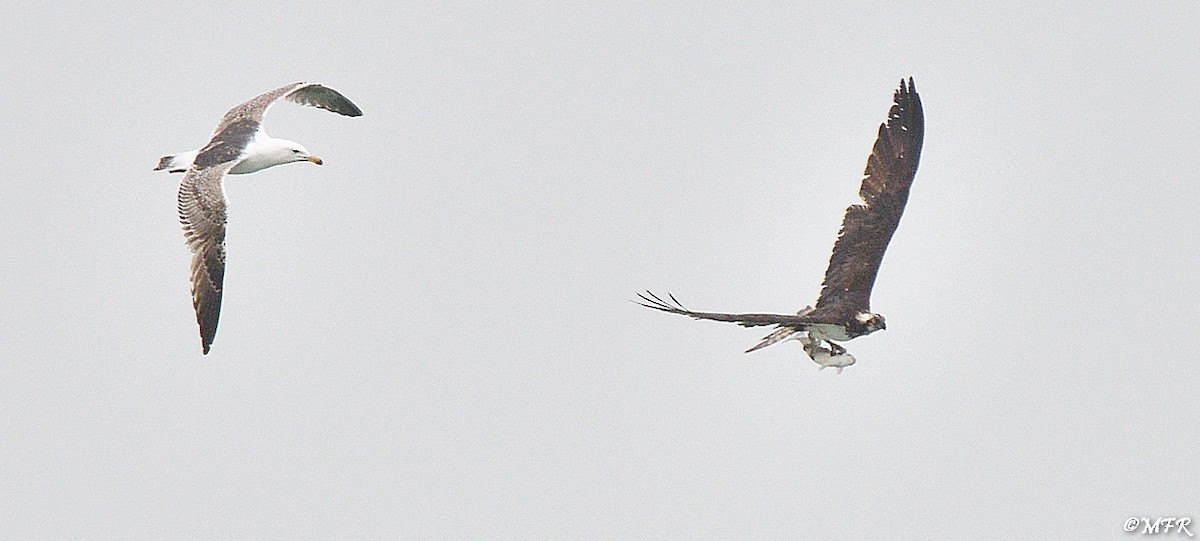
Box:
<box><xmin>812</xmin><ymin>78</ymin><xmax>925</xmax><ymax>319</ymax></box>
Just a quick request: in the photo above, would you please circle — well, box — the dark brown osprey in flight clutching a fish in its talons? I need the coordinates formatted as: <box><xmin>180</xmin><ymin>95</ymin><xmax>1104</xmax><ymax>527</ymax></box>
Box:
<box><xmin>637</xmin><ymin>77</ymin><xmax>925</xmax><ymax>373</ymax></box>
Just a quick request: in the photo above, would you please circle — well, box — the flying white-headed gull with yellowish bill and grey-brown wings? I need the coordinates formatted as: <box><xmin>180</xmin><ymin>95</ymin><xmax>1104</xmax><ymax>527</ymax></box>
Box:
<box><xmin>155</xmin><ymin>83</ymin><xmax>362</xmax><ymax>355</ymax></box>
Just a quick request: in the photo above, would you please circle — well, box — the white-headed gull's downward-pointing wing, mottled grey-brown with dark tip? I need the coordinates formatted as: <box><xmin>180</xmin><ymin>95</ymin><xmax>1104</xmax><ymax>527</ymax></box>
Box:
<box><xmin>179</xmin><ymin>162</ymin><xmax>234</xmax><ymax>354</ymax></box>
